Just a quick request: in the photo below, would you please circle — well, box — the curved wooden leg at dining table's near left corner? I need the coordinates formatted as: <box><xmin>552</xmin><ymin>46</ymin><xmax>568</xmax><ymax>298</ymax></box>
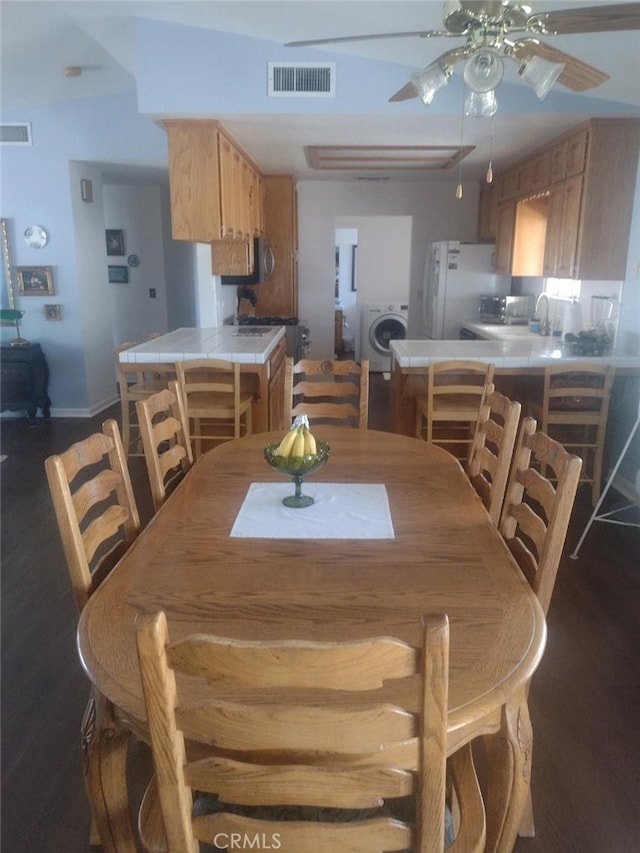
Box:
<box><xmin>82</xmin><ymin>689</ymin><xmax>137</xmax><ymax>853</ymax></box>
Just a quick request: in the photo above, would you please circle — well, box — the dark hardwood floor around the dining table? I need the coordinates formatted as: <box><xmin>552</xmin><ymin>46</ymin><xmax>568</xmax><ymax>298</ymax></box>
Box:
<box><xmin>0</xmin><ymin>374</ymin><xmax>640</xmax><ymax>853</ymax></box>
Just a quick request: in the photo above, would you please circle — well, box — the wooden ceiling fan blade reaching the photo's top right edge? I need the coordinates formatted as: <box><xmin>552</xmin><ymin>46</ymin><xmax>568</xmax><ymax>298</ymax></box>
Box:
<box><xmin>527</xmin><ymin>3</ymin><xmax>640</xmax><ymax>35</ymax></box>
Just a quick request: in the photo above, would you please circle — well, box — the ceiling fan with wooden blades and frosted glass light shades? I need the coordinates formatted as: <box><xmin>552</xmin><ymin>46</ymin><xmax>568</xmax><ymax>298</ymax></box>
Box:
<box><xmin>287</xmin><ymin>0</ymin><xmax>640</xmax><ymax>110</ymax></box>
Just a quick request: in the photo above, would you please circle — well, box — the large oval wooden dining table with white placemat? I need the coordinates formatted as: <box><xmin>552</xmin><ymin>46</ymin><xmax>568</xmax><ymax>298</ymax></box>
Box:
<box><xmin>77</xmin><ymin>426</ymin><xmax>546</xmax><ymax>853</ymax></box>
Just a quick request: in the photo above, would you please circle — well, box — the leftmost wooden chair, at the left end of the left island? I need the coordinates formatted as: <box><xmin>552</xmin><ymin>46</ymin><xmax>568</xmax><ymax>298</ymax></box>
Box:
<box><xmin>114</xmin><ymin>341</ymin><xmax>176</xmax><ymax>456</ymax></box>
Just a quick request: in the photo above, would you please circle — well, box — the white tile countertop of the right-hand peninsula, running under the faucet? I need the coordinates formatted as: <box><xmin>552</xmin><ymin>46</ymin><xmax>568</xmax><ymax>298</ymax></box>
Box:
<box><xmin>390</xmin><ymin>323</ymin><xmax>640</xmax><ymax>372</ymax></box>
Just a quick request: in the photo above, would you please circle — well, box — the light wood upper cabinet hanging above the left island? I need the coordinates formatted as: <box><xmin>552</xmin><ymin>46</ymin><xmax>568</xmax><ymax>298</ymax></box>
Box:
<box><xmin>165</xmin><ymin>120</ymin><xmax>263</xmax><ymax>274</ymax></box>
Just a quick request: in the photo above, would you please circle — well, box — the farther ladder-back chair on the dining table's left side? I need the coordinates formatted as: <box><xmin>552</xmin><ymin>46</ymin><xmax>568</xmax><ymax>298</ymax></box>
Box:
<box><xmin>136</xmin><ymin>380</ymin><xmax>193</xmax><ymax>512</ymax></box>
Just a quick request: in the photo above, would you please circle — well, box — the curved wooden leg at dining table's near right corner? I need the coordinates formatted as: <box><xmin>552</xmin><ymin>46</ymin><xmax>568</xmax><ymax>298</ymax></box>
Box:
<box><xmin>484</xmin><ymin>685</ymin><xmax>533</xmax><ymax>853</ymax></box>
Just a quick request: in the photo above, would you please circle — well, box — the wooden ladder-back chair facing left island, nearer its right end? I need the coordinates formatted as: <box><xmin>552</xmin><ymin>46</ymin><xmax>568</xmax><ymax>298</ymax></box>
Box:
<box><xmin>176</xmin><ymin>358</ymin><xmax>253</xmax><ymax>459</ymax></box>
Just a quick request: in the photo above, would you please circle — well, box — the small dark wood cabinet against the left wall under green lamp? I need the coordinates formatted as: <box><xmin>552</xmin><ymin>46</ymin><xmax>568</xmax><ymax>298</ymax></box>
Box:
<box><xmin>0</xmin><ymin>344</ymin><xmax>51</xmax><ymax>424</ymax></box>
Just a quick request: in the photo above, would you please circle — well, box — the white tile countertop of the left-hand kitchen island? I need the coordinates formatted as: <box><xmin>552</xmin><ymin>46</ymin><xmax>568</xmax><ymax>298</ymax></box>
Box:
<box><xmin>115</xmin><ymin>326</ymin><xmax>285</xmax><ymax>364</ymax></box>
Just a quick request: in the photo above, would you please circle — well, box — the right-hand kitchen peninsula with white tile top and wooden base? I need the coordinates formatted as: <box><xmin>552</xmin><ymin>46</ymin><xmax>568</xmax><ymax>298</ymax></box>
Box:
<box><xmin>390</xmin><ymin>330</ymin><xmax>640</xmax><ymax>435</ymax></box>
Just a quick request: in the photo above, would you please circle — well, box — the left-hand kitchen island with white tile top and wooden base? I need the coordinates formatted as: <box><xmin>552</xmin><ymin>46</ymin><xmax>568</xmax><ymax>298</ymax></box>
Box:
<box><xmin>119</xmin><ymin>326</ymin><xmax>287</xmax><ymax>432</ymax></box>
